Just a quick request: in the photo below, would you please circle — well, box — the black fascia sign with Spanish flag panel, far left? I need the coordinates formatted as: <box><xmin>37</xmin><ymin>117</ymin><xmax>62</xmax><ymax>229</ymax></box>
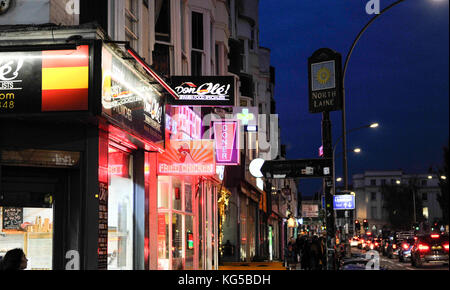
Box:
<box><xmin>0</xmin><ymin>45</ymin><xmax>89</xmax><ymax>114</ymax></box>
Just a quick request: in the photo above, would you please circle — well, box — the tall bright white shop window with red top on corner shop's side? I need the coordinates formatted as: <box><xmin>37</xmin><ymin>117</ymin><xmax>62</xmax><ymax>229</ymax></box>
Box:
<box><xmin>108</xmin><ymin>147</ymin><xmax>134</xmax><ymax>270</ymax></box>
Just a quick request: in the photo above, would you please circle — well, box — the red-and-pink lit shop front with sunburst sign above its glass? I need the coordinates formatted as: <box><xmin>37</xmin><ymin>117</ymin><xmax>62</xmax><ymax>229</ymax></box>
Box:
<box><xmin>157</xmin><ymin>106</ymin><xmax>220</xmax><ymax>270</ymax></box>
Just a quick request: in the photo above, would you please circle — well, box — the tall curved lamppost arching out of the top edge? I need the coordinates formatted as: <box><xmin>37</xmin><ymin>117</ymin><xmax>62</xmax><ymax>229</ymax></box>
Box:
<box><xmin>342</xmin><ymin>0</ymin><xmax>405</xmax><ymax>190</ymax></box>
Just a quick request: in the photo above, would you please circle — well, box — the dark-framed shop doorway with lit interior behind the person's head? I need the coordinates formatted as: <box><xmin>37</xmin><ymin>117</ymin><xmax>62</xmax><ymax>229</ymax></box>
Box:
<box><xmin>0</xmin><ymin>166</ymin><xmax>66</xmax><ymax>270</ymax></box>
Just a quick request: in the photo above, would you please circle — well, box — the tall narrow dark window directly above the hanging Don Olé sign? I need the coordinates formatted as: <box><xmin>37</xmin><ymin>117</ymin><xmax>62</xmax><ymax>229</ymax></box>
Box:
<box><xmin>191</xmin><ymin>12</ymin><xmax>204</xmax><ymax>76</ymax></box>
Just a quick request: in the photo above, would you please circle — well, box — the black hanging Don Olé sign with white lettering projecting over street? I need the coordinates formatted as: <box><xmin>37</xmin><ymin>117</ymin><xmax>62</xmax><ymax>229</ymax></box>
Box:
<box><xmin>171</xmin><ymin>76</ymin><xmax>235</xmax><ymax>106</ymax></box>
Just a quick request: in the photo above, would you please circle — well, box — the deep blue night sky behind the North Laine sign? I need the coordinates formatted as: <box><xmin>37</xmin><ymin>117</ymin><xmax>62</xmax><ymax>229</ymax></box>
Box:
<box><xmin>259</xmin><ymin>0</ymin><xmax>449</xmax><ymax>196</ymax></box>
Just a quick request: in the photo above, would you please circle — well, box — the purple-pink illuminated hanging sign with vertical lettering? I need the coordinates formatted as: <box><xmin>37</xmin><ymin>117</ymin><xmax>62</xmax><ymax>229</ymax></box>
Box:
<box><xmin>212</xmin><ymin>120</ymin><xmax>240</xmax><ymax>165</ymax></box>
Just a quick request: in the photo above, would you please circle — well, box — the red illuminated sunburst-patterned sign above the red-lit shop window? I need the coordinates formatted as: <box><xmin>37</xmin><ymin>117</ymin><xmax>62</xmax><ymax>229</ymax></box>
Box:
<box><xmin>158</xmin><ymin>140</ymin><xmax>216</xmax><ymax>175</ymax></box>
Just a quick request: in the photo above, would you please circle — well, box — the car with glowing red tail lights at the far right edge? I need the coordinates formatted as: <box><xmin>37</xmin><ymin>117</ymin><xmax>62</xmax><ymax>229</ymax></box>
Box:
<box><xmin>411</xmin><ymin>233</ymin><xmax>449</xmax><ymax>268</ymax></box>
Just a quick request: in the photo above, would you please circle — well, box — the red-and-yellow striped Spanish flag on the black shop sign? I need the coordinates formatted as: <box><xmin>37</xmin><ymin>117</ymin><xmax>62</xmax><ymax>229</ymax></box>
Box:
<box><xmin>42</xmin><ymin>45</ymin><xmax>89</xmax><ymax>112</ymax></box>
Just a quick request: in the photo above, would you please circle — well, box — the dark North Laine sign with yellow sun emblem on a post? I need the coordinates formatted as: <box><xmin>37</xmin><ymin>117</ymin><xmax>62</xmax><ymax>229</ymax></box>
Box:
<box><xmin>308</xmin><ymin>48</ymin><xmax>342</xmax><ymax>113</ymax></box>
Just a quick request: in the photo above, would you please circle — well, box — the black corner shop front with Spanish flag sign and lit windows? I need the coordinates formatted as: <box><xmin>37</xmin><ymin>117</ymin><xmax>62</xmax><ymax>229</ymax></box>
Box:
<box><xmin>0</xmin><ymin>28</ymin><xmax>172</xmax><ymax>270</ymax></box>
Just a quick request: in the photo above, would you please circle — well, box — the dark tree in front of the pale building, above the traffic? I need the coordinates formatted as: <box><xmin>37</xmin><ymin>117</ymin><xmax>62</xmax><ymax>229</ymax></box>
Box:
<box><xmin>381</xmin><ymin>178</ymin><xmax>424</xmax><ymax>230</ymax></box>
